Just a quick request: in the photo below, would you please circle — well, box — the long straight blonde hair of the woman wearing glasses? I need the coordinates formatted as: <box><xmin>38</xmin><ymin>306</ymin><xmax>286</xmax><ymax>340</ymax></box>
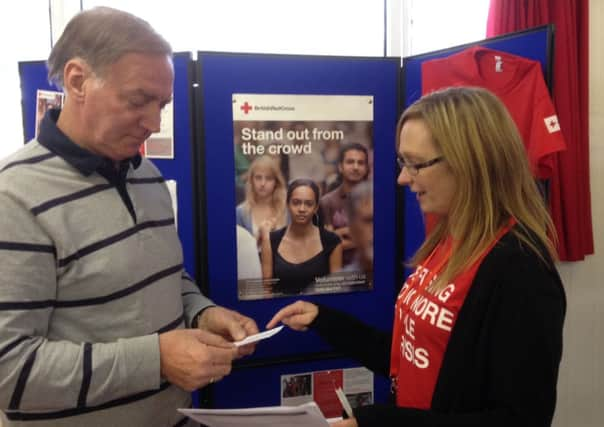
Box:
<box><xmin>397</xmin><ymin>87</ymin><xmax>556</xmax><ymax>291</ymax></box>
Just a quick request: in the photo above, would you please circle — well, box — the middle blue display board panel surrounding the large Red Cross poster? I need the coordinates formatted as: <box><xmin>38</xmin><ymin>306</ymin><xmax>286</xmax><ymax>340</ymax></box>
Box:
<box><xmin>198</xmin><ymin>53</ymin><xmax>400</xmax><ymax>359</ymax></box>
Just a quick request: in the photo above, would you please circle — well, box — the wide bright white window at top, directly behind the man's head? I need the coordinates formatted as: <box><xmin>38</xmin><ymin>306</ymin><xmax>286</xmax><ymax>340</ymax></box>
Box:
<box><xmin>83</xmin><ymin>0</ymin><xmax>384</xmax><ymax>56</ymax></box>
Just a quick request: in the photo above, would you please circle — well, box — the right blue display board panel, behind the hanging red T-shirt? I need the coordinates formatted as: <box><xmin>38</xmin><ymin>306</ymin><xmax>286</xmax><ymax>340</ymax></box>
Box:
<box><xmin>401</xmin><ymin>25</ymin><xmax>553</xmax><ymax>266</ymax></box>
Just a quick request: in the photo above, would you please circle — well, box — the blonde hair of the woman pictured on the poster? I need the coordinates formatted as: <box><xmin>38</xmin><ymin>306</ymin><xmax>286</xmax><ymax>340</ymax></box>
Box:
<box><xmin>244</xmin><ymin>156</ymin><xmax>287</xmax><ymax>228</ymax></box>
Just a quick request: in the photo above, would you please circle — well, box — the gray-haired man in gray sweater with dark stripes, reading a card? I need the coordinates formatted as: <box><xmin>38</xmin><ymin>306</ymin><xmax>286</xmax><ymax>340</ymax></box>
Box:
<box><xmin>0</xmin><ymin>8</ymin><xmax>258</xmax><ymax>426</ymax></box>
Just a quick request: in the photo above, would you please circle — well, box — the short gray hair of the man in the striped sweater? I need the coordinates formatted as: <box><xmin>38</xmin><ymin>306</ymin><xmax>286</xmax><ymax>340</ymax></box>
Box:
<box><xmin>47</xmin><ymin>7</ymin><xmax>172</xmax><ymax>87</ymax></box>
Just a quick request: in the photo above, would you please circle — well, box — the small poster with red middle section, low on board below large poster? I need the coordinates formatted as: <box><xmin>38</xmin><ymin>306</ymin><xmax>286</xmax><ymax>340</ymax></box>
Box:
<box><xmin>280</xmin><ymin>368</ymin><xmax>374</xmax><ymax>418</ymax></box>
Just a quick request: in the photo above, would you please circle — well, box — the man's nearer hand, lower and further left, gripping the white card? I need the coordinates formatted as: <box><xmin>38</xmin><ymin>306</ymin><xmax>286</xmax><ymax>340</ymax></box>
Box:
<box><xmin>159</xmin><ymin>329</ymin><xmax>237</xmax><ymax>391</ymax></box>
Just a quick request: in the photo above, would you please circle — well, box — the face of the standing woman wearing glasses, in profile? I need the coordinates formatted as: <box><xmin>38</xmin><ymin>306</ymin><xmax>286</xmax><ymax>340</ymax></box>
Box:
<box><xmin>397</xmin><ymin>119</ymin><xmax>457</xmax><ymax>216</ymax></box>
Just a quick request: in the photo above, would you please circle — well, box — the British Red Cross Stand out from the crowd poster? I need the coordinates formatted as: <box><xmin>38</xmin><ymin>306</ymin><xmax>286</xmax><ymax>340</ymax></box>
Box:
<box><xmin>233</xmin><ymin>94</ymin><xmax>373</xmax><ymax>300</ymax></box>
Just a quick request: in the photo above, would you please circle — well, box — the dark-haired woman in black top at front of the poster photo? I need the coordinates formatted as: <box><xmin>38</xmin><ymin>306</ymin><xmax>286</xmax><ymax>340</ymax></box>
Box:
<box><xmin>261</xmin><ymin>178</ymin><xmax>342</xmax><ymax>294</ymax></box>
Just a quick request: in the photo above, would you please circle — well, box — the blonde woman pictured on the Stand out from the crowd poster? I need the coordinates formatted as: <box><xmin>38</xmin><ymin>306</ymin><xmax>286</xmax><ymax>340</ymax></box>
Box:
<box><xmin>236</xmin><ymin>156</ymin><xmax>287</xmax><ymax>244</ymax></box>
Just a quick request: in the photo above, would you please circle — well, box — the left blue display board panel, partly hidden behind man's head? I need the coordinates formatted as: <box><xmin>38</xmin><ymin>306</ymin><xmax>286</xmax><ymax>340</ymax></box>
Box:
<box><xmin>19</xmin><ymin>53</ymin><xmax>197</xmax><ymax>275</ymax></box>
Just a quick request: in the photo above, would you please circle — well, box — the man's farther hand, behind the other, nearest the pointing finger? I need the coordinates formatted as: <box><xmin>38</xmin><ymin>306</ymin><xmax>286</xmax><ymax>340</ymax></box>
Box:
<box><xmin>197</xmin><ymin>306</ymin><xmax>258</xmax><ymax>357</ymax></box>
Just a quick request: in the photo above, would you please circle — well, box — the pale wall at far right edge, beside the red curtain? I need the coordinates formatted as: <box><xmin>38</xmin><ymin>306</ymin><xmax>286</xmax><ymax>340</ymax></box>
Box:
<box><xmin>554</xmin><ymin>0</ymin><xmax>604</xmax><ymax>427</ymax></box>
